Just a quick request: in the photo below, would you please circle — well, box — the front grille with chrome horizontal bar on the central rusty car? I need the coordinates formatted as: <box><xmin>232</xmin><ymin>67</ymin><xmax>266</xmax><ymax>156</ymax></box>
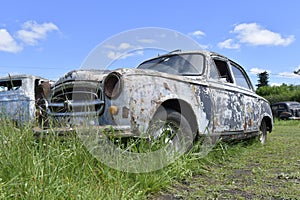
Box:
<box><xmin>48</xmin><ymin>81</ymin><xmax>104</xmax><ymax>116</ymax></box>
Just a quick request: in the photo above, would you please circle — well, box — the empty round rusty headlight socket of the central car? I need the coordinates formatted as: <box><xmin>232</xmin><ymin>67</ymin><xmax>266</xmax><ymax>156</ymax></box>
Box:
<box><xmin>104</xmin><ymin>72</ymin><xmax>122</xmax><ymax>98</ymax></box>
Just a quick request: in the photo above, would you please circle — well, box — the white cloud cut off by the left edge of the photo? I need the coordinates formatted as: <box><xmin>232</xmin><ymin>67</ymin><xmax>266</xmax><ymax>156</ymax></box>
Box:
<box><xmin>0</xmin><ymin>29</ymin><xmax>23</xmax><ymax>53</ymax></box>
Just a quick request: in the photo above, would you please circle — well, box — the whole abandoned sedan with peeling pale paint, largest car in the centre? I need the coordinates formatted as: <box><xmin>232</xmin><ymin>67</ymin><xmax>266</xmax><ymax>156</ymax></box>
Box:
<box><xmin>37</xmin><ymin>50</ymin><xmax>273</xmax><ymax>148</ymax></box>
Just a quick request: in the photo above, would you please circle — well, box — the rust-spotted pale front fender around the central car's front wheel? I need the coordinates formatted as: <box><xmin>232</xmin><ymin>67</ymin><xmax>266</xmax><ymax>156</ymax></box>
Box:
<box><xmin>106</xmin><ymin>75</ymin><xmax>208</xmax><ymax>136</ymax></box>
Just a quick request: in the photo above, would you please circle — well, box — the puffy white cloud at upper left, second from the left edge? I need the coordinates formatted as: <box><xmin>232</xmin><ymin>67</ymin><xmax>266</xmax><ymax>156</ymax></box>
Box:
<box><xmin>17</xmin><ymin>21</ymin><xmax>59</xmax><ymax>46</ymax></box>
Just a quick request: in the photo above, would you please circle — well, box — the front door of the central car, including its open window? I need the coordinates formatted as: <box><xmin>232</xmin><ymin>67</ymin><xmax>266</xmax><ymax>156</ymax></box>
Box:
<box><xmin>208</xmin><ymin>56</ymin><xmax>245</xmax><ymax>134</ymax></box>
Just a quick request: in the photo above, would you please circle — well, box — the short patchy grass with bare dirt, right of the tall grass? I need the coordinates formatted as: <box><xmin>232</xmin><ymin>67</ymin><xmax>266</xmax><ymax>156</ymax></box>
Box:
<box><xmin>152</xmin><ymin>121</ymin><xmax>300</xmax><ymax>199</ymax></box>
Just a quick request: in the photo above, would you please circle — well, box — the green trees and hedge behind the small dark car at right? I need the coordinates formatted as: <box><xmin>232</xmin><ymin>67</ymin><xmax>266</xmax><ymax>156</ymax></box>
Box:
<box><xmin>256</xmin><ymin>71</ymin><xmax>300</xmax><ymax>104</ymax></box>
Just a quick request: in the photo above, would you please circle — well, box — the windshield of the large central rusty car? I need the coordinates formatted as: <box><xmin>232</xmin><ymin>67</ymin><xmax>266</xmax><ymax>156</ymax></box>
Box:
<box><xmin>138</xmin><ymin>53</ymin><xmax>204</xmax><ymax>76</ymax></box>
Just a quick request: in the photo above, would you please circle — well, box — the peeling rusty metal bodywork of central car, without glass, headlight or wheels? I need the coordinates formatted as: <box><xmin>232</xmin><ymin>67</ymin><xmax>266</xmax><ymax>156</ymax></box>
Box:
<box><xmin>42</xmin><ymin>51</ymin><xmax>273</xmax><ymax>140</ymax></box>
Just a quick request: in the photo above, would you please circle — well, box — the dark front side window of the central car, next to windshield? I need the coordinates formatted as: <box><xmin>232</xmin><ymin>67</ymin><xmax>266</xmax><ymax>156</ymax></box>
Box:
<box><xmin>210</xmin><ymin>59</ymin><xmax>233</xmax><ymax>83</ymax></box>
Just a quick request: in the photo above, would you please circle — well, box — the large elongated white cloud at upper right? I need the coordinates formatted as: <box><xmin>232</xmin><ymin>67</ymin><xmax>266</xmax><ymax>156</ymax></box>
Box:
<box><xmin>232</xmin><ymin>23</ymin><xmax>295</xmax><ymax>46</ymax></box>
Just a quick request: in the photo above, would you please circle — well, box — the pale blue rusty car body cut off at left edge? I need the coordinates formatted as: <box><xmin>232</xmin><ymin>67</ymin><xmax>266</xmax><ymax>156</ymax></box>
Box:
<box><xmin>0</xmin><ymin>74</ymin><xmax>50</xmax><ymax>124</ymax></box>
